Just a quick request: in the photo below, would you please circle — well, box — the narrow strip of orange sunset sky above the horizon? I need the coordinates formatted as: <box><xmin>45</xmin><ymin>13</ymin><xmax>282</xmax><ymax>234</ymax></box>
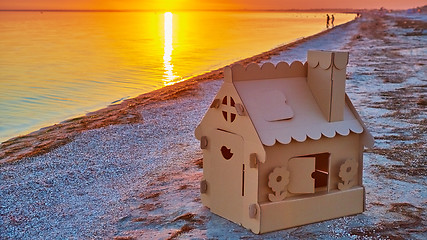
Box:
<box><xmin>0</xmin><ymin>0</ymin><xmax>426</xmax><ymax>11</ymax></box>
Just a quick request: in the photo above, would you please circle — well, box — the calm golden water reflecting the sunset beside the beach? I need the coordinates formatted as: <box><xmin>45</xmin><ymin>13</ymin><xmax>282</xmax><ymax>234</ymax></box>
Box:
<box><xmin>0</xmin><ymin>12</ymin><xmax>354</xmax><ymax>142</ymax></box>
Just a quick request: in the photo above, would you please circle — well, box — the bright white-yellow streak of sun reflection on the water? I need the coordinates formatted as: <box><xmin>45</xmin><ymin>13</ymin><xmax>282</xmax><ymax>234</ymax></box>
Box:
<box><xmin>163</xmin><ymin>12</ymin><xmax>181</xmax><ymax>86</ymax></box>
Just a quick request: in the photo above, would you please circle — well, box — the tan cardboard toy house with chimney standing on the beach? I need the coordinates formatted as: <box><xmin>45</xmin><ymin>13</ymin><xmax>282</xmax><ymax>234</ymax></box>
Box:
<box><xmin>195</xmin><ymin>51</ymin><xmax>373</xmax><ymax>233</ymax></box>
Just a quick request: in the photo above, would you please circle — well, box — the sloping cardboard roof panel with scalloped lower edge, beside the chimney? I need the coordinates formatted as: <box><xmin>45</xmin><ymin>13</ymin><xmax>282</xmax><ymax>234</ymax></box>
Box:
<box><xmin>234</xmin><ymin>77</ymin><xmax>369</xmax><ymax>146</ymax></box>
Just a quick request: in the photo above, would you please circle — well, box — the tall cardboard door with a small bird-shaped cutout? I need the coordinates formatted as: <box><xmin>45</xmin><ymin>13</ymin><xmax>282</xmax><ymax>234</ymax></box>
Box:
<box><xmin>208</xmin><ymin>130</ymin><xmax>244</xmax><ymax>223</ymax></box>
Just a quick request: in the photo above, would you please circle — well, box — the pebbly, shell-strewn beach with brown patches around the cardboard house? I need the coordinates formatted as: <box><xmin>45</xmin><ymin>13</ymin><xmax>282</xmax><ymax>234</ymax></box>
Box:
<box><xmin>0</xmin><ymin>11</ymin><xmax>427</xmax><ymax>240</ymax></box>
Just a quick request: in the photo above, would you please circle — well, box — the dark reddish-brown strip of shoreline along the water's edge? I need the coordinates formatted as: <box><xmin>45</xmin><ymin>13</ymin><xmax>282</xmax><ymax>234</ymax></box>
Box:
<box><xmin>0</xmin><ymin>20</ymin><xmax>355</xmax><ymax>164</ymax></box>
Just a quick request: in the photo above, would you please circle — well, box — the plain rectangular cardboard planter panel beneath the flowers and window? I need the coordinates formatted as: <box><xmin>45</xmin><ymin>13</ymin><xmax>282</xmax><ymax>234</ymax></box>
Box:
<box><xmin>259</xmin><ymin>187</ymin><xmax>365</xmax><ymax>233</ymax></box>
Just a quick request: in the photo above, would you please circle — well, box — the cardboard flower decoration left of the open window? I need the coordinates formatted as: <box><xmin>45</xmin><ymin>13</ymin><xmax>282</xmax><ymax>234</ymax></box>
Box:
<box><xmin>268</xmin><ymin>167</ymin><xmax>289</xmax><ymax>202</ymax></box>
